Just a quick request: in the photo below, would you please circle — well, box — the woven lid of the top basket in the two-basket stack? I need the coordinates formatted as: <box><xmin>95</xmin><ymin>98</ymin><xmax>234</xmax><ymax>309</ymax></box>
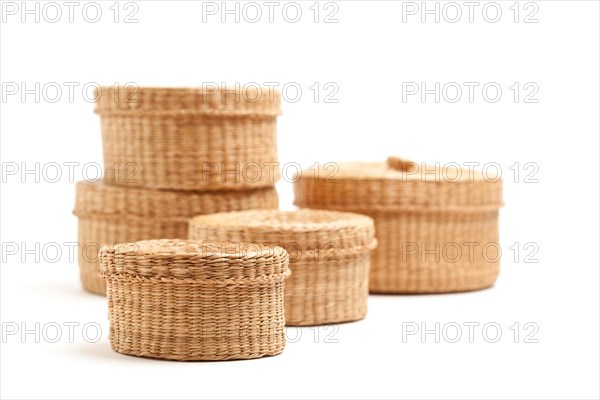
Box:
<box><xmin>95</xmin><ymin>85</ymin><xmax>281</xmax><ymax>117</ymax></box>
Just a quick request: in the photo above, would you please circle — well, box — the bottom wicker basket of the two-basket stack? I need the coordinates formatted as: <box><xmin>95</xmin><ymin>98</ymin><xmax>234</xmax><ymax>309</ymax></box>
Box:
<box><xmin>73</xmin><ymin>182</ymin><xmax>278</xmax><ymax>294</ymax></box>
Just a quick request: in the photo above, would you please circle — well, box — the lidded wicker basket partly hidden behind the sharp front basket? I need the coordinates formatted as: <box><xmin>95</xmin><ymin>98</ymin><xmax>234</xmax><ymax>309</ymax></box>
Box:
<box><xmin>189</xmin><ymin>210</ymin><xmax>376</xmax><ymax>326</ymax></box>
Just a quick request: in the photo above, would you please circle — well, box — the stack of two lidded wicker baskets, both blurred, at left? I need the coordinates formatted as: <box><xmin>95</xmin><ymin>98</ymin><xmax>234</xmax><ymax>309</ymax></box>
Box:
<box><xmin>74</xmin><ymin>87</ymin><xmax>280</xmax><ymax>294</ymax></box>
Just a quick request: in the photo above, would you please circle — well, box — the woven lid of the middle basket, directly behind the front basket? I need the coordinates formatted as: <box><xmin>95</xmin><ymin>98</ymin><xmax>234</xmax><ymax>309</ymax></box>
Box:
<box><xmin>189</xmin><ymin>209</ymin><xmax>377</xmax><ymax>259</ymax></box>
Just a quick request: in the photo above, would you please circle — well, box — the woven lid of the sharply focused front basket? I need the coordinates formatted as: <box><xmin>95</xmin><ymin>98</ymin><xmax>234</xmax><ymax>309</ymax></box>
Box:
<box><xmin>100</xmin><ymin>239</ymin><xmax>290</xmax><ymax>284</ymax></box>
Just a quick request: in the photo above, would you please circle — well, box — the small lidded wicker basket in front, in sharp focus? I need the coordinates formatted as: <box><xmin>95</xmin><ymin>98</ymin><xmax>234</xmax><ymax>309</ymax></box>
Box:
<box><xmin>100</xmin><ymin>240</ymin><xmax>290</xmax><ymax>361</ymax></box>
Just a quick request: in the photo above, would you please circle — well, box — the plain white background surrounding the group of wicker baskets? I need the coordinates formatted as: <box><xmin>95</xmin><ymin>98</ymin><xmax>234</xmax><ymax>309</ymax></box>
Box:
<box><xmin>0</xmin><ymin>1</ymin><xmax>600</xmax><ymax>399</ymax></box>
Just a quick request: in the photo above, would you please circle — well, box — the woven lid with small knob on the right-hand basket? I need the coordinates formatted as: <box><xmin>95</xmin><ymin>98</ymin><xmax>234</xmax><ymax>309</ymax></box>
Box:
<box><xmin>294</xmin><ymin>157</ymin><xmax>503</xmax><ymax>212</ymax></box>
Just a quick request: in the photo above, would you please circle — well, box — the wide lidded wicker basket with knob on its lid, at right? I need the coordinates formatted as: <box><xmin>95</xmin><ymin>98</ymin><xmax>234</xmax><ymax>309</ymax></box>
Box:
<box><xmin>294</xmin><ymin>158</ymin><xmax>502</xmax><ymax>293</ymax></box>
